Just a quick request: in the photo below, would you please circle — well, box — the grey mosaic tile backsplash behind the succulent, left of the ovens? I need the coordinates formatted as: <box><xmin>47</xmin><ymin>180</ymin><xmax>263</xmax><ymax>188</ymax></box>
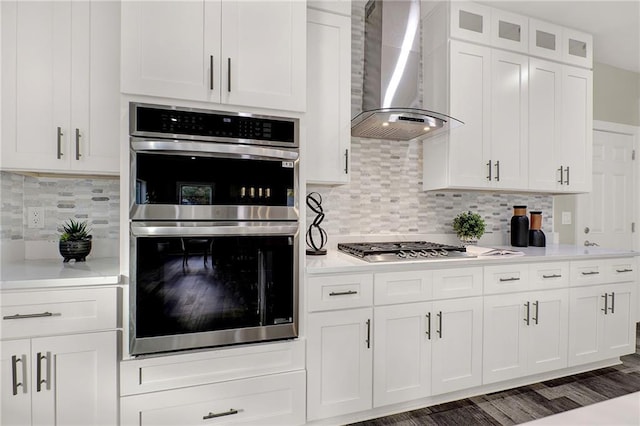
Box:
<box><xmin>0</xmin><ymin>172</ymin><xmax>120</xmax><ymax>241</ymax></box>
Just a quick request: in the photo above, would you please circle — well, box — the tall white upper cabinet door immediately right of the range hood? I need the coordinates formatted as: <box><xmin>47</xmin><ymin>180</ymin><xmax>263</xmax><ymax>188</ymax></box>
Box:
<box><xmin>448</xmin><ymin>41</ymin><xmax>491</xmax><ymax>188</ymax></box>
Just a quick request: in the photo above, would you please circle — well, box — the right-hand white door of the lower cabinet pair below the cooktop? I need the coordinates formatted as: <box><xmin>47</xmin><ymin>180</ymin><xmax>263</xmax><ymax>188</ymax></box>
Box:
<box><xmin>430</xmin><ymin>297</ymin><xmax>482</xmax><ymax>395</ymax></box>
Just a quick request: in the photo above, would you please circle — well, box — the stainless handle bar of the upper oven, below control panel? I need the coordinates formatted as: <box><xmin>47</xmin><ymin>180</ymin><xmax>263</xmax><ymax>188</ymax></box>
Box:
<box><xmin>131</xmin><ymin>138</ymin><xmax>298</xmax><ymax>161</ymax></box>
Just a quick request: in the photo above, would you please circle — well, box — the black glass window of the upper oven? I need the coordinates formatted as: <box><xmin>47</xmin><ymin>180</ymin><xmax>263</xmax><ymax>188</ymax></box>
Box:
<box><xmin>136</xmin><ymin>153</ymin><xmax>294</xmax><ymax>206</ymax></box>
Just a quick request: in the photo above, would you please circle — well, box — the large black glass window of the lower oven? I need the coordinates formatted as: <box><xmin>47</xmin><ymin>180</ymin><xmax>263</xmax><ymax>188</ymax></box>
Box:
<box><xmin>135</xmin><ymin>236</ymin><xmax>295</xmax><ymax>337</ymax></box>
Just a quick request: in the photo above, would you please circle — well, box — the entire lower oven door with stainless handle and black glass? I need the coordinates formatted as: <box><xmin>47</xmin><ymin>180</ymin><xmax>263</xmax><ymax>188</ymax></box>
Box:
<box><xmin>129</xmin><ymin>222</ymin><xmax>299</xmax><ymax>355</ymax></box>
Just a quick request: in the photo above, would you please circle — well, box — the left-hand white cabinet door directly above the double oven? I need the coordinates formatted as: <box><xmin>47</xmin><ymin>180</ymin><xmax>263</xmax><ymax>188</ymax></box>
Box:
<box><xmin>121</xmin><ymin>0</ymin><xmax>222</xmax><ymax>102</ymax></box>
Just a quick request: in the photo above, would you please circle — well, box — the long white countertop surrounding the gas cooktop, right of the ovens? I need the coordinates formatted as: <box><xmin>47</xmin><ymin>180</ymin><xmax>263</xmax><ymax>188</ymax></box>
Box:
<box><xmin>306</xmin><ymin>244</ymin><xmax>640</xmax><ymax>274</ymax></box>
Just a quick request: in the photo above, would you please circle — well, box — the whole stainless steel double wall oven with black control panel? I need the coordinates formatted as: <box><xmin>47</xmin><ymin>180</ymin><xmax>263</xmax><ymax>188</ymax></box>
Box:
<box><xmin>129</xmin><ymin>103</ymin><xmax>299</xmax><ymax>355</ymax></box>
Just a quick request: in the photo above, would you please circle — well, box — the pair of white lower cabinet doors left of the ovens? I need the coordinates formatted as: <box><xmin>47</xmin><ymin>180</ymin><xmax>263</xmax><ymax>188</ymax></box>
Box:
<box><xmin>0</xmin><ymin>331</ymin><xmax>118</xmax><ymax>426</ymax></box>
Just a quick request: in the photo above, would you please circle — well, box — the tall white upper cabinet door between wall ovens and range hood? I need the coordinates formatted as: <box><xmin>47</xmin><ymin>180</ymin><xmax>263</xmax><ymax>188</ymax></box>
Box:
<box><xmin>305</xmin><ymin>9</ymin><xmax>351</xmax><ymax>183</ymax></box>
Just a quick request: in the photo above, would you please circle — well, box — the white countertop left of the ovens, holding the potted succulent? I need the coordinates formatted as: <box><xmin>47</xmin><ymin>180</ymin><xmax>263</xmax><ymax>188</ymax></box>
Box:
<box><xmin>0</xmin><ymin>257</ymin><xmax>120</xmax><ymax>290</ymax></box>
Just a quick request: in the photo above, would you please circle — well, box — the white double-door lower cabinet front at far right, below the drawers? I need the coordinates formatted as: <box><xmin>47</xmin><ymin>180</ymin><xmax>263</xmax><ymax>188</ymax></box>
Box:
<box><xmin>569</xmin><ymin>282</ymin><xmax>637</xmax><ymax>366</ymax></box>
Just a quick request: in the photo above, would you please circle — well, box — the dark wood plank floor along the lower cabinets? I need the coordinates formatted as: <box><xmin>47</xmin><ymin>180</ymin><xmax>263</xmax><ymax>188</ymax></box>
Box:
<box><xmin>353</xmin><ymin>325</ymin><xmax>640</xmax><ymax>426</ymax></box>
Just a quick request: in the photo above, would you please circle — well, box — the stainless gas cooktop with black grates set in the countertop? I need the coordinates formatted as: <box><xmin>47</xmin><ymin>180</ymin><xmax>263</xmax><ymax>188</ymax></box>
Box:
<box><xmin>338</xmin><ymin>241</ymin><xmax>475</xmax><ymax>262</ymax></box>
